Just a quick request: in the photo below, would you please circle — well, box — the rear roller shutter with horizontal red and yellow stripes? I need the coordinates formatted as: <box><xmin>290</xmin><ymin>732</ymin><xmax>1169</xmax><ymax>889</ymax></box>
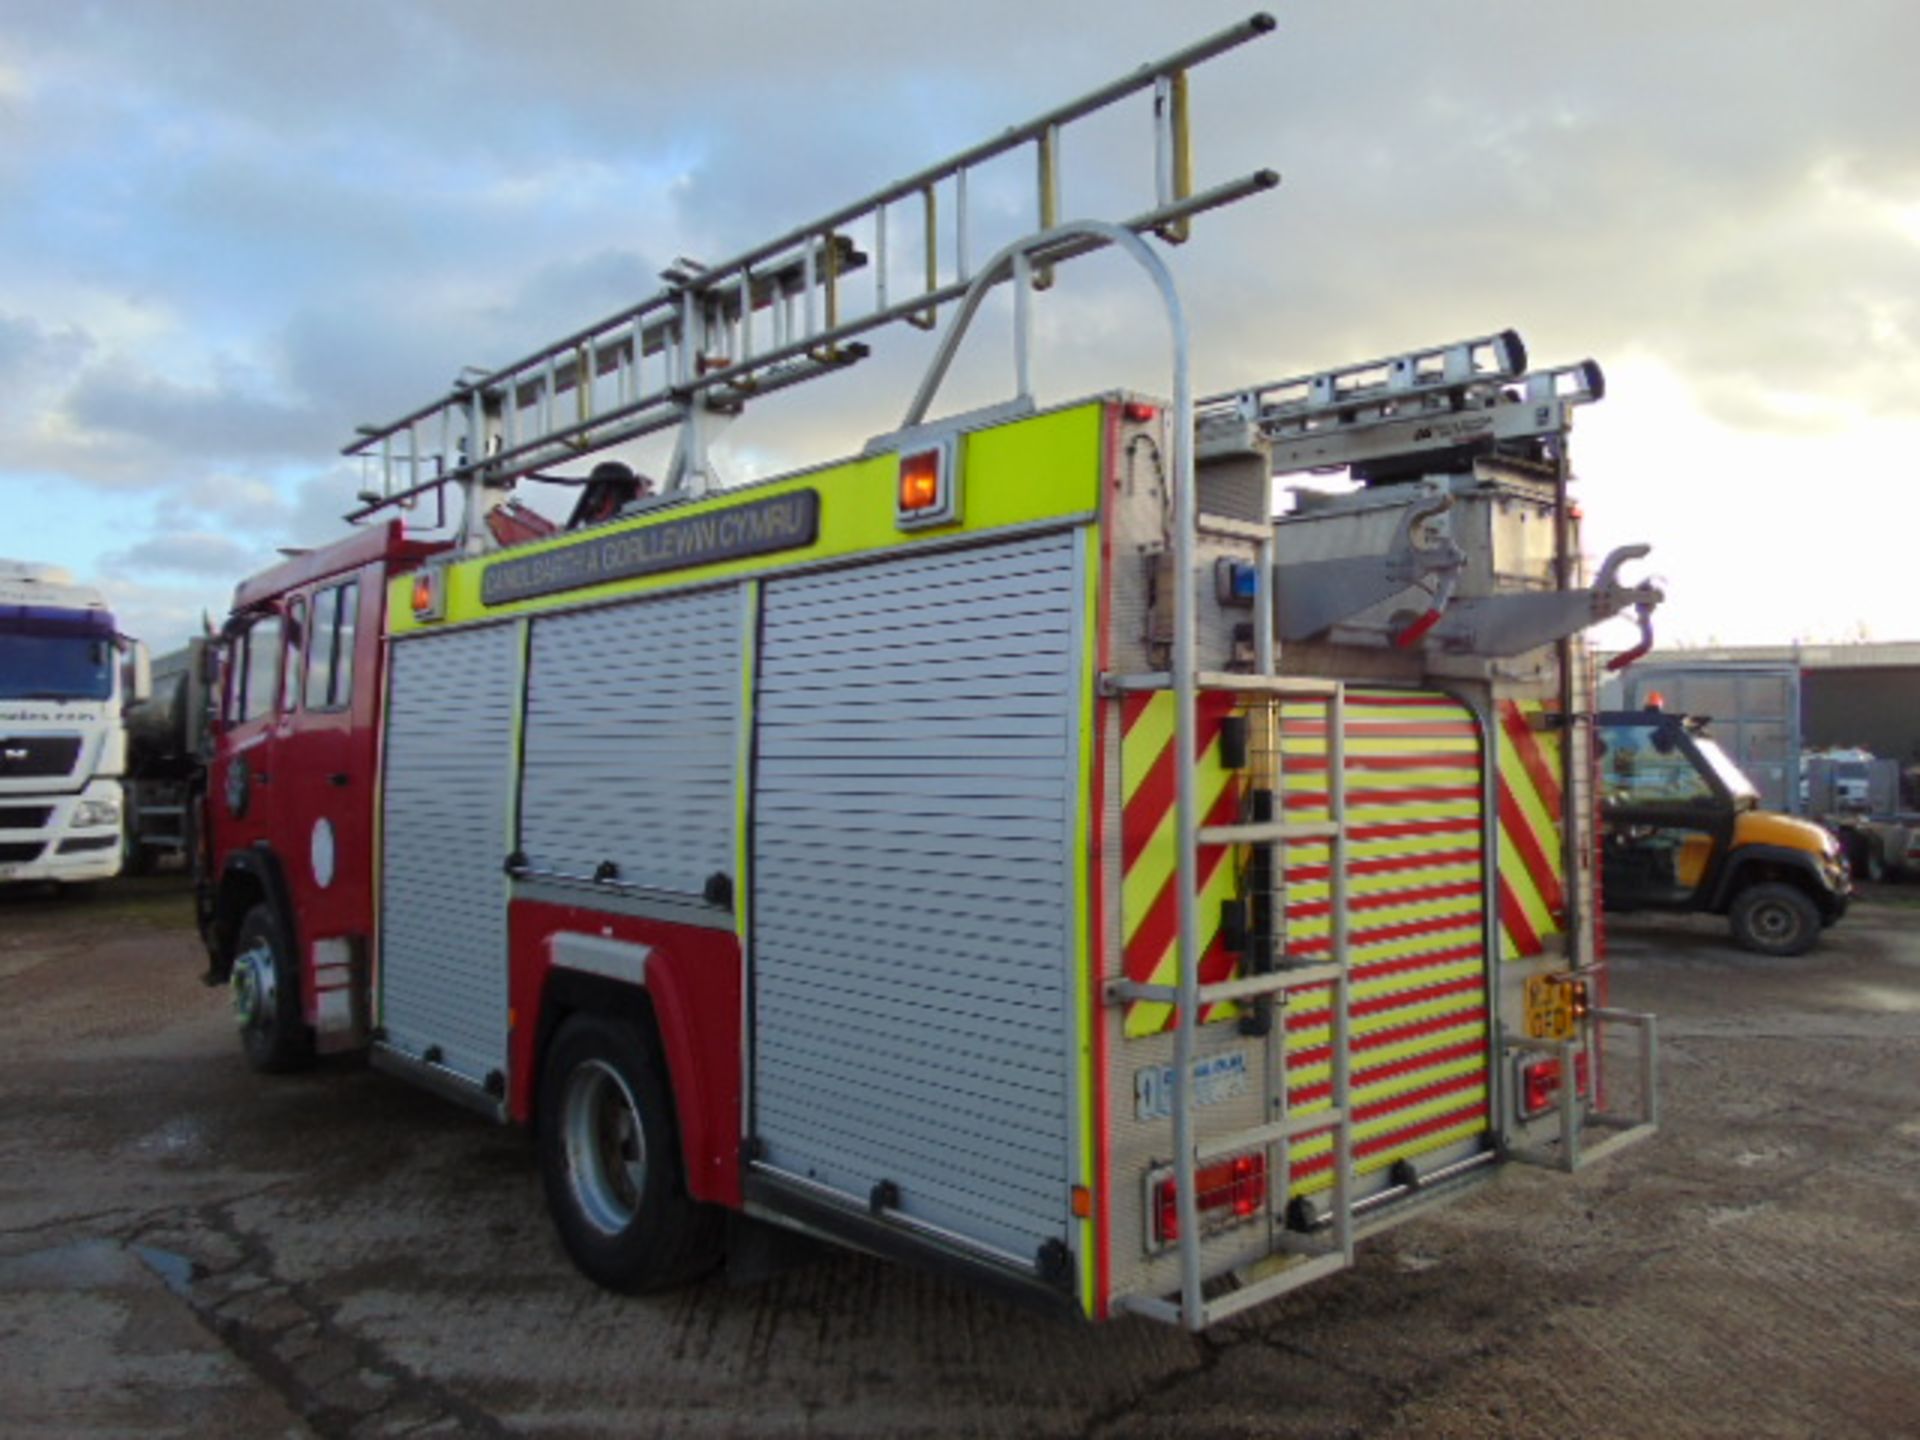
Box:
<box><xmin>1281</xmin><ymin>691</ymin><xmax>1488</xmax><ymax>1194</ymax></box>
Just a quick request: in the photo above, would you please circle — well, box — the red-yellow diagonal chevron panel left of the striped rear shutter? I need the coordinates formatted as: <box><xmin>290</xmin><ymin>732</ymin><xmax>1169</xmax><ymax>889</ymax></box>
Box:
<box><xmin>1119</xmin><ymin>691</ymin><xmax>1240</xmax><ymax>1037</ymax></box>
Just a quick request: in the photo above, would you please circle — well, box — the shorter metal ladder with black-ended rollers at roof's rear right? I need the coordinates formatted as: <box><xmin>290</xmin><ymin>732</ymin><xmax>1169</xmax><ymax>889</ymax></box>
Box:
<box><xmin>1194</xmin><ymin>330</ymin><xmax>1607</xmax><ymax>474</ymax></box>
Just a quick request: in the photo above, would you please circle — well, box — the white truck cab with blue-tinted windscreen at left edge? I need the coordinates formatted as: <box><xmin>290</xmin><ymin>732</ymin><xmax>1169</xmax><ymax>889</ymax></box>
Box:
<box><xmin>0</xmin><ymin>561</ymin><xmax>148</xmax><ymax>883</ymax></box>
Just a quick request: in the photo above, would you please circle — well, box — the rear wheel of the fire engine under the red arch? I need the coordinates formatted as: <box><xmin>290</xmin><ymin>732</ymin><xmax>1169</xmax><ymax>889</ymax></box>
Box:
<box><xmin>538</xmin><ymin>1016</ymin><xmax>720</xmax><ymax>1294</ymax></box>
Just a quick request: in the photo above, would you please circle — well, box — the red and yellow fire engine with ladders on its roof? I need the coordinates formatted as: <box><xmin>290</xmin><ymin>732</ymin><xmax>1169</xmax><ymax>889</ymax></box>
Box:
<box><xmin>191</xmin><ymin>15</ymin><xmax>1659</xmax><ymax>1331</ymax></box>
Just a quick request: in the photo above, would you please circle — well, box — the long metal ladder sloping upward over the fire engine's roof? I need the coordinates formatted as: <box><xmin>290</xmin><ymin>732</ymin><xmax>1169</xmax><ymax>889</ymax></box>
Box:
<box><xmin>344</xmin><ymin>13</ymin><xmax>1279</xmax><ymax>536</ymax></box>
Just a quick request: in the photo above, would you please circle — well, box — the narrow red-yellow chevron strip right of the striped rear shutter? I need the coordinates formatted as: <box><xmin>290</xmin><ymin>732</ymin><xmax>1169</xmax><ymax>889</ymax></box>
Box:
<box><xmin>1498</xmin><ymin>701</ymin><xmax>1567</xmax><ymax>960</ymax></box>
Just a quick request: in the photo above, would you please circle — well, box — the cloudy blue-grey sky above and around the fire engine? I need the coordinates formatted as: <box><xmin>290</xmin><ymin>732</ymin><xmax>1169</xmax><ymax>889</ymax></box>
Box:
<box><xmin>0</xmin><ymin>0</ymin><xmax>1920</xmax><ymax>647</ymax></box>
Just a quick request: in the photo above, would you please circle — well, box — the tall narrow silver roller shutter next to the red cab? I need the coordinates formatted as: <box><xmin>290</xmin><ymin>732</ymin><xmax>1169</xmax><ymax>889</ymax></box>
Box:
<box><xmin>380</xmin><ymin>626</ymin><xmax>520</xmax><ymax>1085</ymax></box>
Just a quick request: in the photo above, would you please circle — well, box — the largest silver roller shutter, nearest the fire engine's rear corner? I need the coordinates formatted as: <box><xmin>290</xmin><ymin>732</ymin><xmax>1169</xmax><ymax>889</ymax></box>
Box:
<box><xmin>753</xmin><ymin>536</ymin><xmax>1079</xmax><ymax>1258</ymax></box>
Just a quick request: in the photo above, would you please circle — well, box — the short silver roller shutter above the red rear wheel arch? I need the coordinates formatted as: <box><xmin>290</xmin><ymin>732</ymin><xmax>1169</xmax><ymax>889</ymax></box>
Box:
<box><xmin>520</xmin><ymin>588</ymin><xmax>743</xmax><ymax>895</ymax></box>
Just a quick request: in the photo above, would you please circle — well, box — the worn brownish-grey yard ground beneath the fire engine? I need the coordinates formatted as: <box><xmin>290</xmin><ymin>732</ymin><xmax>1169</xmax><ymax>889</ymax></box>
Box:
<box><xmin>0</xmin><ymin>879</ymin><xmax>1920</xmax><ymax>1438</ymax></box>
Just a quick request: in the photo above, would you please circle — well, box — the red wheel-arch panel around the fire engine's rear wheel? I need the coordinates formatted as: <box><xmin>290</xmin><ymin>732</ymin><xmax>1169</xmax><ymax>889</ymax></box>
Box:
<box><xmin>507</xmin><ymin>900</ymin><xmax>741</xmax><ymax>1208</ymax></box>
